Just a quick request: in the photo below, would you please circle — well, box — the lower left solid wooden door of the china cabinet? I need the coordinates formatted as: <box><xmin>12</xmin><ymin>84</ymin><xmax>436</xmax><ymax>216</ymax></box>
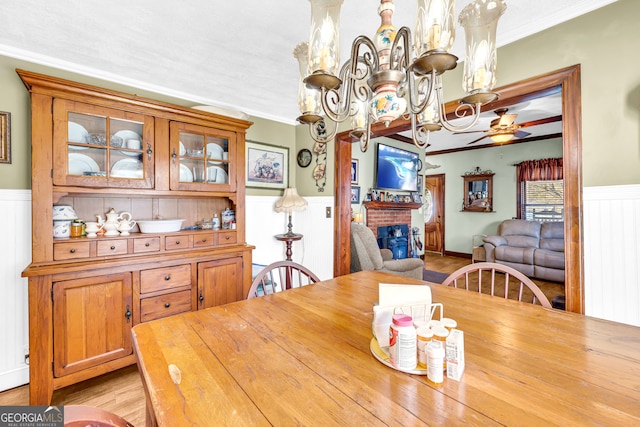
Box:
<box><xmin>53</xmin><ymin>273</ymin><xmax>133</xmax><ymax>377</ymax></box>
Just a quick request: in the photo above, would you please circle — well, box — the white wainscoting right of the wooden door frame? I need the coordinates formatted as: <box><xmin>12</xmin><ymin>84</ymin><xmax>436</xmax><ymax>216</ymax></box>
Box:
<box><xmin>583</xmin><ymin>185</ymin><xmax>640</xmax><ymax>326</ymax></box>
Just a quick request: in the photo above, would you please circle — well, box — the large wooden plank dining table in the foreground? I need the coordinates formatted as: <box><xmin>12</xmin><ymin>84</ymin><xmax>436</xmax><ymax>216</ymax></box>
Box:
<box><xmin>133</xmin><ymin>271</ymin><xmax>640</xmax><ymax>426</ymax></box>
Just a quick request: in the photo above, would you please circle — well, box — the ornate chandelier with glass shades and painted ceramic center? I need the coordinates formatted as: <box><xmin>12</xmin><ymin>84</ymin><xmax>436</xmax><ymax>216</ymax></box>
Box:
<box><xmin>294</xmin><ymin>0</ymin><xmax>507</xmax><ymax>152</ymax></box>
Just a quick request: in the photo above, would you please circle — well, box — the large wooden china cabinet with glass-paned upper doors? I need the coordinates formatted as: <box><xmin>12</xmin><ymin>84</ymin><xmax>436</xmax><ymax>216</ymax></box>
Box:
<box><xmin>17</xmin><ymin>70</ymin><xmax>253</xmax><ymax>405</ymax></box>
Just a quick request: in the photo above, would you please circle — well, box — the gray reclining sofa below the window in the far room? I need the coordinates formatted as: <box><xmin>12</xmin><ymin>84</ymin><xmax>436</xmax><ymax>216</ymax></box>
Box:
<box><xmin>483</xmin><ymin>219</ymin><xmax>564</xmax><ymax>283</ymax></box>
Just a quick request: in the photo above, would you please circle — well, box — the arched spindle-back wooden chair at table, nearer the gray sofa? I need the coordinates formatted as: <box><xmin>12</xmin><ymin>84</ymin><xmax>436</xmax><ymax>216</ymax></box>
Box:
<box><xmin>442</xmin><ymin>262</ymin><xmax>551</xmax><ymax>308</ymax></box>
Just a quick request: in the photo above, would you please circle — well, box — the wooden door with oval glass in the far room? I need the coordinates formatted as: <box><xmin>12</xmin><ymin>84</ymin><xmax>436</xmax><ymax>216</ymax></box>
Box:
<box><xmin>423</xmin><ymin>174</ymin><xmax>445</xmax><ymax>255</ymax></box>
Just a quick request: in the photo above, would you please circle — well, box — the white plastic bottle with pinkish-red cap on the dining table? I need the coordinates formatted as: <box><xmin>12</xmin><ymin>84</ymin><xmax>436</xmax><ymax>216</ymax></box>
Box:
<box><xmin>389</xmin><ymin>314</ymin><xmax>418</xmax><ymax>371</ymax></box>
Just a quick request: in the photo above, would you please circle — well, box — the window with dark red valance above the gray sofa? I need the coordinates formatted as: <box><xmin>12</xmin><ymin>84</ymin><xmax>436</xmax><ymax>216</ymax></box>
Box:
<box><xmin>516</xmin><ymin>158</ymin><xmax>564</xmax><ymax>222</ymax></box>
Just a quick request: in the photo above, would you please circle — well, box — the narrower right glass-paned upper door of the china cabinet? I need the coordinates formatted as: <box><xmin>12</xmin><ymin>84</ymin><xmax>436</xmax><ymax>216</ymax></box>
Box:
<box><xmin>169</xmin><ymin>122</ymin><xmax>238</xmax><ymax>192</ymax></box>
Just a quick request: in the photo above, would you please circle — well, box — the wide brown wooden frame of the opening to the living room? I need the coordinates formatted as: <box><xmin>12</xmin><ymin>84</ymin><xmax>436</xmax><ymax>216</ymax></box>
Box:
<box><xmin>333</xmin><ymin>64</ymin><xmax>584</xmax><ymax>314</ymax></box>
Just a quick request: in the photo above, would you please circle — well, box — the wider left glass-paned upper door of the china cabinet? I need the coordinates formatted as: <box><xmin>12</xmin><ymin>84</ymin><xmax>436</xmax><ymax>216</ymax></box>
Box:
<box><xmin>53</xmin><ymin>99</ymin><xmax>154</xmax><ymax>188</ymax></box>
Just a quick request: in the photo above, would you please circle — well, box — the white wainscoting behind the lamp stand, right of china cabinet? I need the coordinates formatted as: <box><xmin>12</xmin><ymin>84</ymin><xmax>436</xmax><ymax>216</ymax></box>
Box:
<box><xmin>246</xmin><ymin>196</ymin><xmax>335</xmax><ymax>280</ymax></box>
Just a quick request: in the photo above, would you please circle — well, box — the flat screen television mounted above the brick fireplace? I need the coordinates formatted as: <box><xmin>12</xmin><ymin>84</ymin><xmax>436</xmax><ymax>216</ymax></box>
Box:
<box><xmin>376</xmin><ymin>143</ymin><xmax>419</xmax><ymax>191</ymax></box>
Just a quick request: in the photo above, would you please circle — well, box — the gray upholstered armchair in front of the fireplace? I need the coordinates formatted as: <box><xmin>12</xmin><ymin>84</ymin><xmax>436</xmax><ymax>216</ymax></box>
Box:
<box><xmin>351</xmin><ymin>222</ymin><xmax>424</xmax><ymax>280</ymax></box>
